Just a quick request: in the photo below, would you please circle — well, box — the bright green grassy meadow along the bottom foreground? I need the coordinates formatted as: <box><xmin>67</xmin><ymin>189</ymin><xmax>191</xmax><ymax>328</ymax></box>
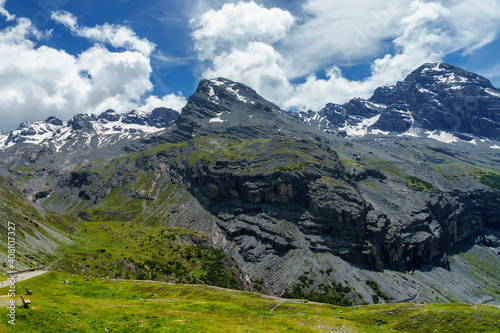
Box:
<box><xmin>0</xmin><ymin>272</ymin><xmax>500</xmax><ymax>332</ymax></box>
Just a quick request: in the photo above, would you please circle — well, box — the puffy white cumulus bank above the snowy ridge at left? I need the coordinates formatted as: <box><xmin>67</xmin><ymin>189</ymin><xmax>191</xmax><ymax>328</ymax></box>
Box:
<box><xmin>0</xmin><ymin>15</ymin><xmax>185</xmax><ymax>129</ymax></box>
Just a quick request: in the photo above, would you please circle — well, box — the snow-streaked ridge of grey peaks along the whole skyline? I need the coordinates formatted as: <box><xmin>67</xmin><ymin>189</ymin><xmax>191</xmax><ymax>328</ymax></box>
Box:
<box><xmin>0</xmin><ymin>63</ymin><xmax>500</xmax><ymax>152</ymax></box>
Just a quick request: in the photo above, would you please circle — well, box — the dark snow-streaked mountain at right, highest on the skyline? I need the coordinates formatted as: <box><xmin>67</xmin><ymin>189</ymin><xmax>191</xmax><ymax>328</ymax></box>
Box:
<box><xmin>299</xmin><ymin>63</ymin><xmax>500</xmax><ymax>140</ymax></box>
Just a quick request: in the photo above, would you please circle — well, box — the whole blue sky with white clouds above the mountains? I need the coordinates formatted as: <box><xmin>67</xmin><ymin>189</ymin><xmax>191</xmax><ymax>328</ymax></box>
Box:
<box><xmin>0</xmin><ymin>0</ymin><xmax>500</xmax><ymax>130</ymax></box>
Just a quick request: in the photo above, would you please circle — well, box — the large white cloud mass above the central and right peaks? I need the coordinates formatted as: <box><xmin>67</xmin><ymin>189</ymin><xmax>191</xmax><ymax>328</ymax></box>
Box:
<box><xmin>192</xmin><ymin>0</ymin><xmax>500</xmax><ymax>110</ymax></box>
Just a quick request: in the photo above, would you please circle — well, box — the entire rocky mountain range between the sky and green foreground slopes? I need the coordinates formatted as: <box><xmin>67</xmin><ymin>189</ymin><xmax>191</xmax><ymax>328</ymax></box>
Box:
<box><xmin>0</xmin><ymin>63</ymin><xmax>500</xmax><ymax>304</ymax></box>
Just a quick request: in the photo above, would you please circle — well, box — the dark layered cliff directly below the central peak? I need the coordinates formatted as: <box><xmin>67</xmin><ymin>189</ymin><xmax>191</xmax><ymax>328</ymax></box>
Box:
<box><xmin>172</xmin><ymin>139</ymin><xmax>372</xmax><ymax>268</ymax></box>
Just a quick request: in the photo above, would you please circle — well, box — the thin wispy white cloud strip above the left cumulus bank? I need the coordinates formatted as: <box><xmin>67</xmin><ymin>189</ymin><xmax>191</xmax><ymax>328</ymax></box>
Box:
<box><xmin>51</xmin><ymin>11</ymin><xmax>156</xmax><ymax>57</ymax></box>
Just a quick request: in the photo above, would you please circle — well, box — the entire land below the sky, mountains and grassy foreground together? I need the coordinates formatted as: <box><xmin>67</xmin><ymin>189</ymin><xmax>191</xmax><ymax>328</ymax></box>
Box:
<box><xmin>0</xmin><ymin>64</ymin><xmax>500</xmax><ymax>332</ymax></box>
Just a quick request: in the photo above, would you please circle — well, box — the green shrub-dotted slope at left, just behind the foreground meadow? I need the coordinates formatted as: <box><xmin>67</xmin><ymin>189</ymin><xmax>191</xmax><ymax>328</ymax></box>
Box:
<box><xmin>54</xmin><ymin>222</ymin><xmax>240</xmax><ymax>288</ymax></box>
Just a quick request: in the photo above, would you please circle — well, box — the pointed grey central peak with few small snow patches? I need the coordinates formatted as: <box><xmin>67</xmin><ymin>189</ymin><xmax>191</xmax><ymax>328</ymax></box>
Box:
<box><xmin>163</xmin><ymin>78</ymin><xmax>324</xmax><ymax>142</ymax></box>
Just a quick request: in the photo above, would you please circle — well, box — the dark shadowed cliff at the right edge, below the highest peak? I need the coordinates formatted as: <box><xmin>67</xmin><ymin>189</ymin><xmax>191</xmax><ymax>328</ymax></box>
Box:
<box><xmin>362</xmin><ymin>180</ymin><xmax>500</xmax><ymax>272</ymax></box>
